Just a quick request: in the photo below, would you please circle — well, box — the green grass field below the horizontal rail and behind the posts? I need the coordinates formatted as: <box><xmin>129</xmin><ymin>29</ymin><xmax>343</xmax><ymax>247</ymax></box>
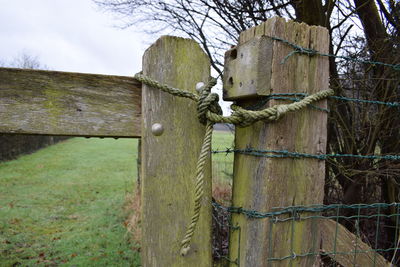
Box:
<box><xmin>0</xmin><ymin>132</ymin><xmax>232</xmax><ymax>267</ymax></box>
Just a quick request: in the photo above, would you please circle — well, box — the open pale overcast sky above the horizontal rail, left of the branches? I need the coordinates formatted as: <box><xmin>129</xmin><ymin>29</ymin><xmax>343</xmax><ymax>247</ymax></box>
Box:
<box><xmin>0</xmin><ymin>0</ymin><xmax>150</xmax><ymax>75</ymax></box>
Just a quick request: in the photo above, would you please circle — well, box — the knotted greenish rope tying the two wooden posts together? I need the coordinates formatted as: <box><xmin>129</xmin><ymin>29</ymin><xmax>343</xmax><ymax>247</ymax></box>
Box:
<box><xmin>135</xmin><ymin>73</ymin><xmax>333</xmax><ymax>256</ymax></box>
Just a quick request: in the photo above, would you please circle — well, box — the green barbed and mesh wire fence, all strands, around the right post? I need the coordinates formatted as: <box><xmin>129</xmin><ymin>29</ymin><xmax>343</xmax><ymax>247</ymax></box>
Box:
<box><xmin>211</xmin><ymin>34</ymin><xmax>400</xmax><ymax>266</ymax></box>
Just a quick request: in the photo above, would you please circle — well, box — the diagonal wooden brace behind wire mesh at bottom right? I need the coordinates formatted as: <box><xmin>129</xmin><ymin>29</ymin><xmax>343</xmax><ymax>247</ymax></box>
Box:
<box><xmin>320</xmin><ymin>219</ymin><xmax>391</xmax><ymax>267</ymax></box>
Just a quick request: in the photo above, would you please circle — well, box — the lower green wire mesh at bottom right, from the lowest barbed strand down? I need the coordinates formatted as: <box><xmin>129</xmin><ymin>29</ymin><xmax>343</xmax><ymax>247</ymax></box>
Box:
<box><xmin>213</xmin><ymin>202</ymin><xmax>400</xmax><ymax>266</ymax></box>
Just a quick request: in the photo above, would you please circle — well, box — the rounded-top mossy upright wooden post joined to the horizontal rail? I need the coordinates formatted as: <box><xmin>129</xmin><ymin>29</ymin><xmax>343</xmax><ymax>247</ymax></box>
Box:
<box><xmin>141</xmin><ymin>36</ymin><xmax>212</xmax><ymax>266</ymax></box>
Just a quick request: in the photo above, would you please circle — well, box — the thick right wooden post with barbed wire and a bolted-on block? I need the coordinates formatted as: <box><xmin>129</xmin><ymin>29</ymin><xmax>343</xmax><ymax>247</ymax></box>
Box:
<box><xmin>224</xmin><ymin>18</ymin><xmax>329</xmax><ymax>267</ymax></box>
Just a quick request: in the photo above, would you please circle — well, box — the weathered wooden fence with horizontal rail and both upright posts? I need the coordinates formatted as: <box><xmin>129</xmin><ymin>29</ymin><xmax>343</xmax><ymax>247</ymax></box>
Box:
<box><xmin>0</xmin><ymin>18</ymin><xmax>386</xmax><ymax>266</ymax></box>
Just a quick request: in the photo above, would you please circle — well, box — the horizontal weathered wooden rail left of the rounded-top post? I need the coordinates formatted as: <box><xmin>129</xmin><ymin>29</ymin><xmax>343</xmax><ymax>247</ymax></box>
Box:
<box><xmin>0</xmin><ymin>68</ymin><xmax>141</xmax><ymax>137</ymax></box>
